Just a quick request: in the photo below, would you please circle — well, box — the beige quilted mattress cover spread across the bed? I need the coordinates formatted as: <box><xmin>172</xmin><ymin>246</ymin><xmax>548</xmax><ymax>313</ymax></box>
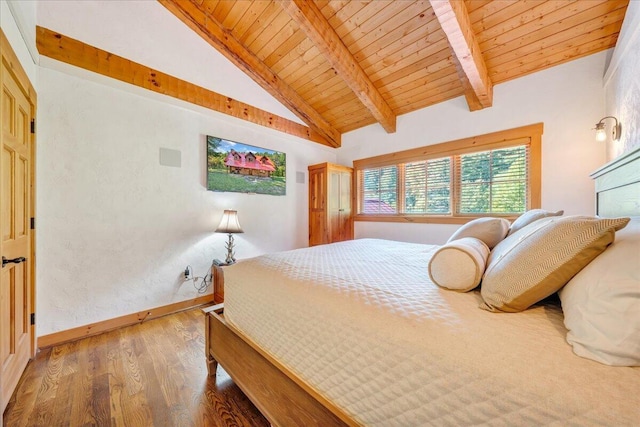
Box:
<box><xmin>225</xmin><ymin>239</ymin><xmax>640</xmax><ymax>426</ymax></box>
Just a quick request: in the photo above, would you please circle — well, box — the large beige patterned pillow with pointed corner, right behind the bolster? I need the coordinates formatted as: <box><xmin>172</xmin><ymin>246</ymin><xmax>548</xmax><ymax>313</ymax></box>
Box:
<box><xmin>481</xmin><ymin>216</ymin><xmax>629</xmax><ymax>312</ymax></box>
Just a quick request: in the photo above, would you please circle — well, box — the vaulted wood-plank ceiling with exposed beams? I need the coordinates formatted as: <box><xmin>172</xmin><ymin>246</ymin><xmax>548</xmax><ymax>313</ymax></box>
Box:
<box><xmin>39</xmin><ymin>0</ymin><xmax>629</xmax><ymax>147</ymax></box>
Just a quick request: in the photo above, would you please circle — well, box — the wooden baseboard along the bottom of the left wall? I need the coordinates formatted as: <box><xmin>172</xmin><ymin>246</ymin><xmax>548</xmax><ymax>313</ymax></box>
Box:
<box><xmin>38</xmin><ymin>294</ymin><xmax>213</xmax><ymax>348</ymax></box>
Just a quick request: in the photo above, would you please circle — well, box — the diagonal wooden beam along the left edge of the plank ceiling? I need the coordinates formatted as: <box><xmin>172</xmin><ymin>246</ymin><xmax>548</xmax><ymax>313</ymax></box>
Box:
<box><xmin>158</xmin><ymin>0</ymin><xmax>341</xmax><ymax>147</ymax></box>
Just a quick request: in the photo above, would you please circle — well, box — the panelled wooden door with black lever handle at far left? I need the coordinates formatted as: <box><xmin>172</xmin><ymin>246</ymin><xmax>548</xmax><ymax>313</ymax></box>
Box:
<box><xmin>0</xmin><ymin>35</ymin><xmax>35</xmax><ymax>411</ymax></box>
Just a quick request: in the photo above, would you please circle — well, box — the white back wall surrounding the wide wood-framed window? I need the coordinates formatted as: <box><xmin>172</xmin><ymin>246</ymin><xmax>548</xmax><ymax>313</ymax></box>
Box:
<box><xmin>338</xmin><ymin>52</ymin><xmax>606</xmax><ymax>244</ymax></box>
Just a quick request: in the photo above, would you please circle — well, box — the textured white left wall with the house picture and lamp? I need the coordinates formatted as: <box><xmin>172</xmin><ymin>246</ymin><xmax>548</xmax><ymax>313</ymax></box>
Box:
<box><xmin>37</xmin><ymin>68</ymin><xmax>336</xmax><ymax>335</ymax></box>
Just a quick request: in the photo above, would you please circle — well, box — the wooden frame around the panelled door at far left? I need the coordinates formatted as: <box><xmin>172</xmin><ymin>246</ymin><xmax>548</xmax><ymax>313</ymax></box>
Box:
<box><xmin>0</xmin><ymin>28</ymin><xmax>37</xmax><ymax>358</ymax></box>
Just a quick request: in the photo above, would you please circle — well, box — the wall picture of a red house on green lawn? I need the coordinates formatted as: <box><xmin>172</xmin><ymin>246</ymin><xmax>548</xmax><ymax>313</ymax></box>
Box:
<box><xmin>207</xmin><ymin>135</ymin><xmax>287</xmax><ymax>196</ymax></box>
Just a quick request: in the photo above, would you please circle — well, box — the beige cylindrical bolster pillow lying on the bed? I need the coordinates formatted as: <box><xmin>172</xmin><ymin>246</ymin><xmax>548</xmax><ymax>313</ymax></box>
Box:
<box><xmin>429</xmin><ymin>237</ymin><xmax>489</xmax><ymax>292</ymax></box>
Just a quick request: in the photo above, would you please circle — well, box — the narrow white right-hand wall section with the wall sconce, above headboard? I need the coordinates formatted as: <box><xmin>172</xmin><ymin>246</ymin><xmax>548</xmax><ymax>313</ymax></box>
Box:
<box><xmin>604</xmin><ymin>1</ymin><xmax>640</xmax><ymax>160</ymax></box>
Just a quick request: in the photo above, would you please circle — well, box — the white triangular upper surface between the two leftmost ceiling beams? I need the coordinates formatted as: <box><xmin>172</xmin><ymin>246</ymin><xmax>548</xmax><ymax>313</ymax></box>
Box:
<box><xmin>37</xmin><ymin>0</ymin><xmax>302</xmax><ymax>123</ymax></box>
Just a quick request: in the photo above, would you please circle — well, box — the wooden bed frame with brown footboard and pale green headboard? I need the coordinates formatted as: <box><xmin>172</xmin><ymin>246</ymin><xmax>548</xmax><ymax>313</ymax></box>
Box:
<box><xmin>204</xmin><ymin>148</ymin><xmax>640</xmax><ymax>426</ymax></box>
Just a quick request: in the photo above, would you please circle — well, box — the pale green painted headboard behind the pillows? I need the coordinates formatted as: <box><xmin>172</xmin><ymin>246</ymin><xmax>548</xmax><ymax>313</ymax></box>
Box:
<box><xmin>591</xmin><ymin>147</ymin><xmax>640</xmax><ymax>221</ymax></box>
